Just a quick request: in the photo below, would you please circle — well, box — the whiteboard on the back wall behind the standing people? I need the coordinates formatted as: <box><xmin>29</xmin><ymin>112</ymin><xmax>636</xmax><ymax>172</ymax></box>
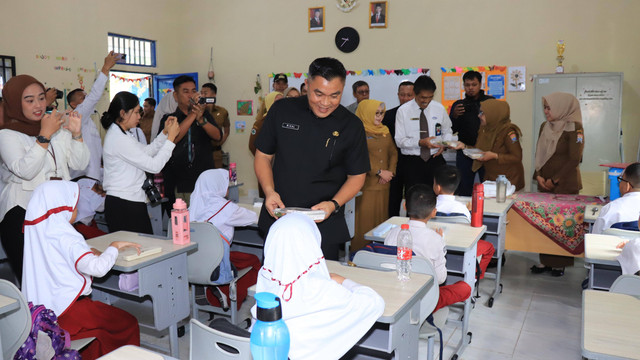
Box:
<box><xmin>267</xmin><ymin>73</ymin><xmax>428</xmax><ymax>109</ymax></box>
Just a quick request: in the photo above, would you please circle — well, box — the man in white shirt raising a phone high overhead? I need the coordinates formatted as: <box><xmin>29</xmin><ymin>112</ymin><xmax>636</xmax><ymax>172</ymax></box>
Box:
<box><xmin>67</xmin><ymin>51</ymin><xmax>119</xmax><ymax>181</ymax></box>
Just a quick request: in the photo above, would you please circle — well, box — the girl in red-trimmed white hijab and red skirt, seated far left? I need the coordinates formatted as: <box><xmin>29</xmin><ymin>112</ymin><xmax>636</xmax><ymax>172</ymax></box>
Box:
<box><xmin>22</xmin><ymin>180</ymin><xmax>140</xmax><ymax>359</ymax></box>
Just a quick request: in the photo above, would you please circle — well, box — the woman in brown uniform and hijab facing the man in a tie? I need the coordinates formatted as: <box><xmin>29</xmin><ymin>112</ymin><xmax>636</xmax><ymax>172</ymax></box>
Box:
<box><xmin>464</xmin><ymin>99</ymin><xmax>524</xmax><ymax>190</ymax></box>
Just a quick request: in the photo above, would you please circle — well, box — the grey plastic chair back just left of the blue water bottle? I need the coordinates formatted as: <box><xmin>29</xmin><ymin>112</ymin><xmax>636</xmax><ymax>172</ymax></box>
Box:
<box><xmin>189</xmin><ymin>318</ymin><xmax>252</xmax><ymax>360</ymax></box>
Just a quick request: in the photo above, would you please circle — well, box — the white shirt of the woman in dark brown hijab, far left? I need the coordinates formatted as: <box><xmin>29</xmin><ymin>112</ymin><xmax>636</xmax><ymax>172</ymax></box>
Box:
<box><xmin>0</xmin><ymin>129</ymin><xmax>89</xmax><ymax>221</ymax></box>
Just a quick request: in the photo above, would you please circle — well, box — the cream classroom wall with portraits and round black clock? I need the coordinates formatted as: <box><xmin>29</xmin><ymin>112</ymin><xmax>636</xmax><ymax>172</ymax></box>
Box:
<box><xmin>0</xmin><ymin>0</ymin><xmax>640</xmax><ymax>194</ymax></box>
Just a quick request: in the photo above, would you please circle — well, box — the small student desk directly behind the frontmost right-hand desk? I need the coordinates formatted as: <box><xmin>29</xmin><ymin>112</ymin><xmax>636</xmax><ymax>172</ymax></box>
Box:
<box><xmin>584</xmin><ymin>234</ymin><xmax>624</xmax><ymax>290</ymax></box>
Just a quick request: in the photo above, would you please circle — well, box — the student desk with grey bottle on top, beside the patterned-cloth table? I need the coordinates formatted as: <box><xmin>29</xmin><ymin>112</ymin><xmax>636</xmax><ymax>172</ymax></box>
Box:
<box><xmin>456</xmin><ymin>196</ymin><xmax>515</xmax><ymax>307</ymax></box>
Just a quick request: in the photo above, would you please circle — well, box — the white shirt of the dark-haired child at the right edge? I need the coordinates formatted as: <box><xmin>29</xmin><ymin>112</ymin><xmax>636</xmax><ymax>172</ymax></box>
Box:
<box><xmin>592</xmin><ymin>191</ymin><xmax>640</xmax><ymax>234</ymax></box>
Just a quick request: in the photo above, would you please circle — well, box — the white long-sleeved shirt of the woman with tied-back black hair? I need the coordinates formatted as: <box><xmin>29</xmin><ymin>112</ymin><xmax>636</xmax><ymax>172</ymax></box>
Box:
<box><xmin>102</xmin><ymin>123</ymin><xmax>176</xmax><ymax>202</ymax></box>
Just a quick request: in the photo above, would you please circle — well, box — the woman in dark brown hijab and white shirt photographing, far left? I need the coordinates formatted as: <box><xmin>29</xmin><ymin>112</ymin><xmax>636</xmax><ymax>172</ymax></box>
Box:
<box><xmin>0</xmin><ymin>75</ymin><xmax>89</xmax><ymax>280</ymax></box>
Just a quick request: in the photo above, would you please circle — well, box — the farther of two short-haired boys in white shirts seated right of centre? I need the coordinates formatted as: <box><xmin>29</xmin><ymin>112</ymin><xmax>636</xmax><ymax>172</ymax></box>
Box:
<box><xmin>433</xmin><ymin>165</ymin><xmax>496</xmax><ymax>279</ymax></box>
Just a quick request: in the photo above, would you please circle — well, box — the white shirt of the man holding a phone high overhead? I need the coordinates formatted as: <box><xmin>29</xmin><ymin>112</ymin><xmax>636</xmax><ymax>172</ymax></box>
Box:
<box><xmin>71</xmin><ymin>71</ymin><xmax>109</xmax><ymax>181</ymax></box>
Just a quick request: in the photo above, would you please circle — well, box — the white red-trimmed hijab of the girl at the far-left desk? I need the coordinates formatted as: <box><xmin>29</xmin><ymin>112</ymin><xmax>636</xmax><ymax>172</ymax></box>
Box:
<box><xmin>22</xmin><ymin>180</ymin><xmax>91</xmax><ymax>316</ymax></box>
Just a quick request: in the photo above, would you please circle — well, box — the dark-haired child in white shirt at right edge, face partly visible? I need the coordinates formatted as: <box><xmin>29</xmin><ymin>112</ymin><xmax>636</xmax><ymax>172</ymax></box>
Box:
<box><xmin>593</xmin><ymin>162</ymin><xmax>640</xmax><ymax>234</ymax></box>
